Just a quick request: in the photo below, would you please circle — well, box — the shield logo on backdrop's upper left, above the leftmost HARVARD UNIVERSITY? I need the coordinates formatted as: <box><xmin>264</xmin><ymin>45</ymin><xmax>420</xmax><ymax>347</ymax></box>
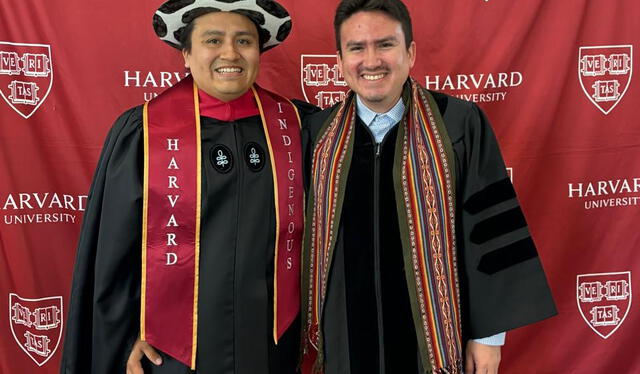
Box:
<box><xmin>0</xmin><ymin>42</ymin><xmax>53</xmax><ymax>118</ymax></box>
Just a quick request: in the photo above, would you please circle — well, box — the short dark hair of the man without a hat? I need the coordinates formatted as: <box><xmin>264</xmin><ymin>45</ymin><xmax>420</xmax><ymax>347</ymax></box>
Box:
<box><xmin>333</xmin><ymin>0</ymin><xmax>413</xmax><ymax>54</ymax></box>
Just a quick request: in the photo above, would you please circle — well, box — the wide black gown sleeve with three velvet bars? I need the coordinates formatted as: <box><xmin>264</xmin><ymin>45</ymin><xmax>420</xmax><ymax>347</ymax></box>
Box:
<box><xmin>445</xmin><ymin>101</ymin><xmax>557</xmax><ymax>339</ymax></box>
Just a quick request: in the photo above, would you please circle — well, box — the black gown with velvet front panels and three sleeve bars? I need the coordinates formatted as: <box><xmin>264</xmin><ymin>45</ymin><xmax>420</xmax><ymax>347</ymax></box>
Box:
<box><xmin>303</xmin><ymin>92</ymin><xmax>556</xmax><ymax>374</ymax></box>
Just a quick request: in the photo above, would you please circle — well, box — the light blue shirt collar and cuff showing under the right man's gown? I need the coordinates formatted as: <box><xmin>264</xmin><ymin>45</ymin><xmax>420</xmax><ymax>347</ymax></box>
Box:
<box><xmin>356</xmin><ymin>95</ymin><xmax>507</xmax><ymax>345</ymax></box>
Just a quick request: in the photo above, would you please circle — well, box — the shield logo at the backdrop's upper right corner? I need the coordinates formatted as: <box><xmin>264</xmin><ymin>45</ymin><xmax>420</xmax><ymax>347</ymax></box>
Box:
<box><xmin>578</xmin><ymin>45</ymin><xmax>633</xmax><ymax>114</ymax></box>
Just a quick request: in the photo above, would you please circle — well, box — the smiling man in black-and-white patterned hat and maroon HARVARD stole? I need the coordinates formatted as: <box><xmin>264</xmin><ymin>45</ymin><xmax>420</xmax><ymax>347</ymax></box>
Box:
<box><xmin>61</xmin><ymin>0</ymin><xmax>315</xmax><ymax>374</ymax></box>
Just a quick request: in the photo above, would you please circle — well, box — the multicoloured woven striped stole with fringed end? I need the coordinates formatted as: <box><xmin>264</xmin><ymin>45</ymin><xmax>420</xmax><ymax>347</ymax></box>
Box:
<box><xmin>302</xmin><ymin>79</ymin><xmax>462</xmax><ymax>374</ymax></box>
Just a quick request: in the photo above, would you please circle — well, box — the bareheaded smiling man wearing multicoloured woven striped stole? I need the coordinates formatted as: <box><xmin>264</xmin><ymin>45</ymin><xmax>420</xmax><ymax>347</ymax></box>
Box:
<box><xmin>302</xmin><ymin>0</ymin><xmax>556</xmax><ymax>374</ymax></box>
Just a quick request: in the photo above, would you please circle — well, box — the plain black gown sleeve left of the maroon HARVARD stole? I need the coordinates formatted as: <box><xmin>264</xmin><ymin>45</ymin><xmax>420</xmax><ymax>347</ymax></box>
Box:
<box><xmin>60</xmin><ymin>107</ymin><xmax>142</xmax><ymax>374</ymax></box>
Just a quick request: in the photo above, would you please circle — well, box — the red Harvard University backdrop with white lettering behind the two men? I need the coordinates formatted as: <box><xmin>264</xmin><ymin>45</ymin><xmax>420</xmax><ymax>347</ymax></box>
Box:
<box><xmin>0</xmin><ymin>0</ymin><xmax>640</xmax><ymax>374</ymax></box>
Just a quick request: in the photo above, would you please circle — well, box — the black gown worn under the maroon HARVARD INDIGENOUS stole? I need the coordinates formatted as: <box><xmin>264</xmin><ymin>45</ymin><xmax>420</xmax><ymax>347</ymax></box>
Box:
<box><xmin>61</xmin><ymin>103</ymin><xmax>315</xmax><ymax>374</ymax></box>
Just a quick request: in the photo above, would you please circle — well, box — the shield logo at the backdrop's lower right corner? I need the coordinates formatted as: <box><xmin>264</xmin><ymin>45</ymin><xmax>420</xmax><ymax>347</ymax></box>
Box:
<box><xmin>576</xmin><ymin>271</ymin><xmax>631</xmax><ymax>339</ymax></box>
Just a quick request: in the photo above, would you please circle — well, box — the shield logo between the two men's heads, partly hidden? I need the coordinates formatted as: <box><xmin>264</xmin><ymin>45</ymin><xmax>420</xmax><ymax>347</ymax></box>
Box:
<box><xmin>300</xmin><ymin>55</ymin><xmax>349</xmax><ymax>109</ymax></box>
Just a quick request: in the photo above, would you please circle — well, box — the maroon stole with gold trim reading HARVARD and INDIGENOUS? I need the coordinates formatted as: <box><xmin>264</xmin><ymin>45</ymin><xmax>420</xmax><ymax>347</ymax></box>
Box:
<box><xmin>140</xmin><ymin>76</ymin><xmax>304</xmax><ymax>370</ymax></box>
